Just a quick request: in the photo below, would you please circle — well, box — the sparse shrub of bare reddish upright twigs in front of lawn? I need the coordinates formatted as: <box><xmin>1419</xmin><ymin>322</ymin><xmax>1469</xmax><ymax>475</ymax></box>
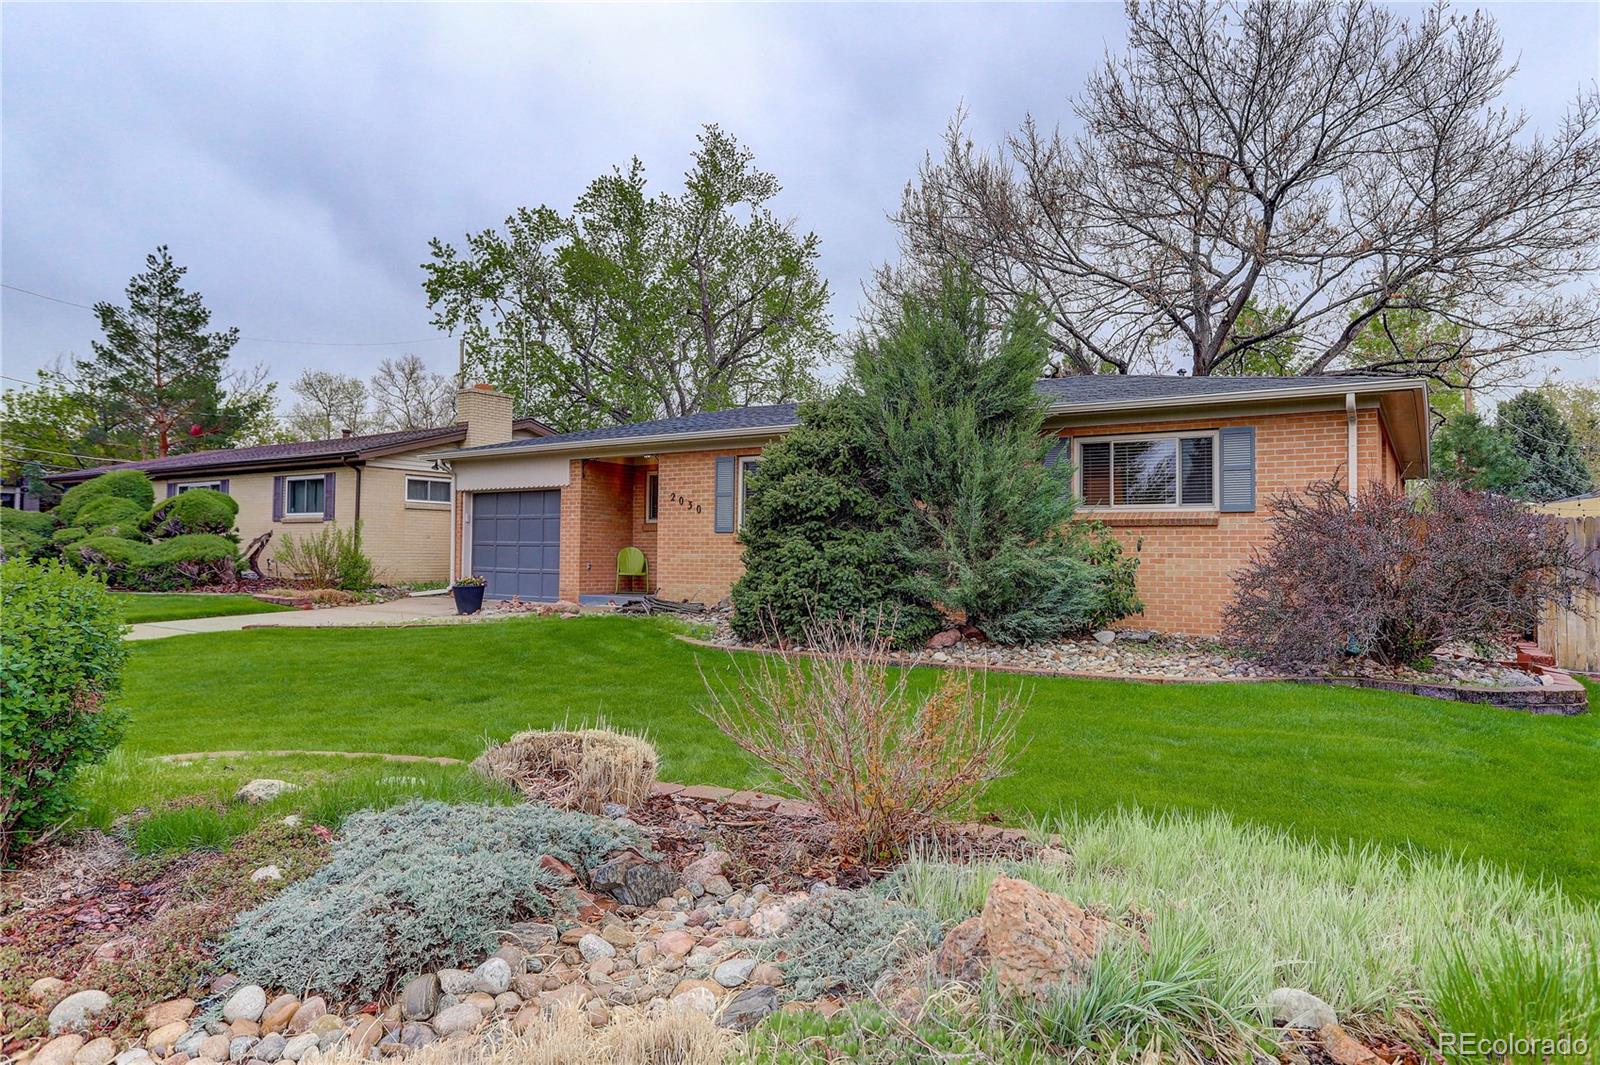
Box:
<box><xmin>701</xmin><ymin>619</ymin><xmax>1026</xmax><ymax>860</ymax></box>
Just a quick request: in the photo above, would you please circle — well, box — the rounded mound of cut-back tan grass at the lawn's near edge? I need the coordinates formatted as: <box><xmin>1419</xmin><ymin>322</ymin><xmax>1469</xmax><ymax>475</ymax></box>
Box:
<box><xmin>472</xmin><ymin>729</ymin><xmax>661</xmax><ymax>814</ymax></box>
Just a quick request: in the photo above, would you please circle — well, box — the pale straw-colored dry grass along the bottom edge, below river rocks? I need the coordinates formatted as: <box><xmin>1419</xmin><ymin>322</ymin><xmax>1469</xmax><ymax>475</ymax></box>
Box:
<box><xmin>320</xmin><ymin>1007</ymin><xmax>741</xmax><ymax>1065</ymax></box>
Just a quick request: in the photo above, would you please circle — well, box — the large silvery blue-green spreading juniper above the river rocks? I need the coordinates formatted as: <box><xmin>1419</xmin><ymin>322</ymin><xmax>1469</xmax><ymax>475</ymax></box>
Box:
<box><xmin>219</xmin><ymin>801</ymin><xmax>646</xmax><ymax>998</ymax></box>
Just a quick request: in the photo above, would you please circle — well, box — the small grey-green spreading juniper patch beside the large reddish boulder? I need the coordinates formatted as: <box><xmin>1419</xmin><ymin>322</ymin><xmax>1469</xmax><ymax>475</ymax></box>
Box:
<box><xmin>750</xmin><ymin>891</ymin><xmax>944</xmax><ymax>999</ymax></box>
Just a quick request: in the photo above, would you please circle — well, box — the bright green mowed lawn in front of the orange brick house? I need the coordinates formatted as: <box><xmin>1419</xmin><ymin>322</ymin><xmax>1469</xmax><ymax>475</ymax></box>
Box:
<box><xmin>116</xmin><ymin>617</ymin><xmax>1600</xmax><ymax>897</ymax></box>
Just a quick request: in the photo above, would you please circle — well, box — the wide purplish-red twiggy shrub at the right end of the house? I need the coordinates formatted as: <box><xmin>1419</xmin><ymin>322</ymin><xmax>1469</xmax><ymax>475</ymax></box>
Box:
<box><xmin>1224</xmin><ymin>481</ymin><xmax>1589</xmax><ymax>668</ymax></box>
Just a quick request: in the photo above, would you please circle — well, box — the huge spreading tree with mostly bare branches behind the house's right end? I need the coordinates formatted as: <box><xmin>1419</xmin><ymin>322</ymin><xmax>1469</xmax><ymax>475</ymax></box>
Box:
<box><xmin>880</xmin><ymin>0</ymin><xmax>1600</xmax><ymax>384</ymax></box>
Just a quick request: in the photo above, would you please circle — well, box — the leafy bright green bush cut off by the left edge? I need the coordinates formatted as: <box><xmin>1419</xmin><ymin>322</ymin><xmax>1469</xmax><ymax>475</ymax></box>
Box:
<box><xmin>0</xmin><ymin>560</ymin><xmax>126</xmax><ymax>865</ymax></box>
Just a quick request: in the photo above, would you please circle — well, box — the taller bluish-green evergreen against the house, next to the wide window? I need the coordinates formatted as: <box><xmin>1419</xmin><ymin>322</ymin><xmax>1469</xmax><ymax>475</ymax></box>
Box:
<box><xmin>853</xmin><ymin>269</ymin><xmax>1133</xmax><ymax>643</ymax></box>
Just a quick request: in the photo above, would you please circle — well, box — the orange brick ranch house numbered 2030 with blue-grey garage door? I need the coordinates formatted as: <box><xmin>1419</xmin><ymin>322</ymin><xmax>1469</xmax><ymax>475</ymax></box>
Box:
<box><xmin>434</xmin><ymin>376</ymin><xmax>1429</xmax><ymax>633</ymax></box>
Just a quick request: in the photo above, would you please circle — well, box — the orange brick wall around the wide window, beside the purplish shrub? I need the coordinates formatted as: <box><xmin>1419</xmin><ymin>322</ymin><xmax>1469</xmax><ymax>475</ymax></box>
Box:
<box><xmin>1064</xmin><ymin>409</ymin><xmax>1398</xmax><ymax>635</ymax></box>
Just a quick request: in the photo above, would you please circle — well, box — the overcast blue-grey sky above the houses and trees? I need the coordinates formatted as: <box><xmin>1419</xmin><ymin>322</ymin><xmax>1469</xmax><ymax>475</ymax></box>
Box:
<box><xmin>0</xmin><ymin>3</ymin><xmax>1600</xmax><ymax>407</ymax></box>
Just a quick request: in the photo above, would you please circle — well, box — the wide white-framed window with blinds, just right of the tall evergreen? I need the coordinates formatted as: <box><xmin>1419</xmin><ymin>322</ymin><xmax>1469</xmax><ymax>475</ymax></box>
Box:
<box><xmin>1077</xmin><ymin>432</ymin><xmax>1218</xmax><ymax>510</ymax></box>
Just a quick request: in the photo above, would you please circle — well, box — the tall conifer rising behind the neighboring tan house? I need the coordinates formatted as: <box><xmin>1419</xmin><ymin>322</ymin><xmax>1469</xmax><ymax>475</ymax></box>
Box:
<box><xmin>77</xmin><ymin>245</ymin><xmax>270</xmax><ymax>456</ymax></box>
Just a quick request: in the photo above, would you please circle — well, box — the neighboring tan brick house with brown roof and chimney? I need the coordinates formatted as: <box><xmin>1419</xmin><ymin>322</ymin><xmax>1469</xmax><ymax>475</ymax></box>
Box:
<box><xmin>50</xmin><ymin>385</ymin><xmax>550</xmax><ymax>580</ymax></box>
